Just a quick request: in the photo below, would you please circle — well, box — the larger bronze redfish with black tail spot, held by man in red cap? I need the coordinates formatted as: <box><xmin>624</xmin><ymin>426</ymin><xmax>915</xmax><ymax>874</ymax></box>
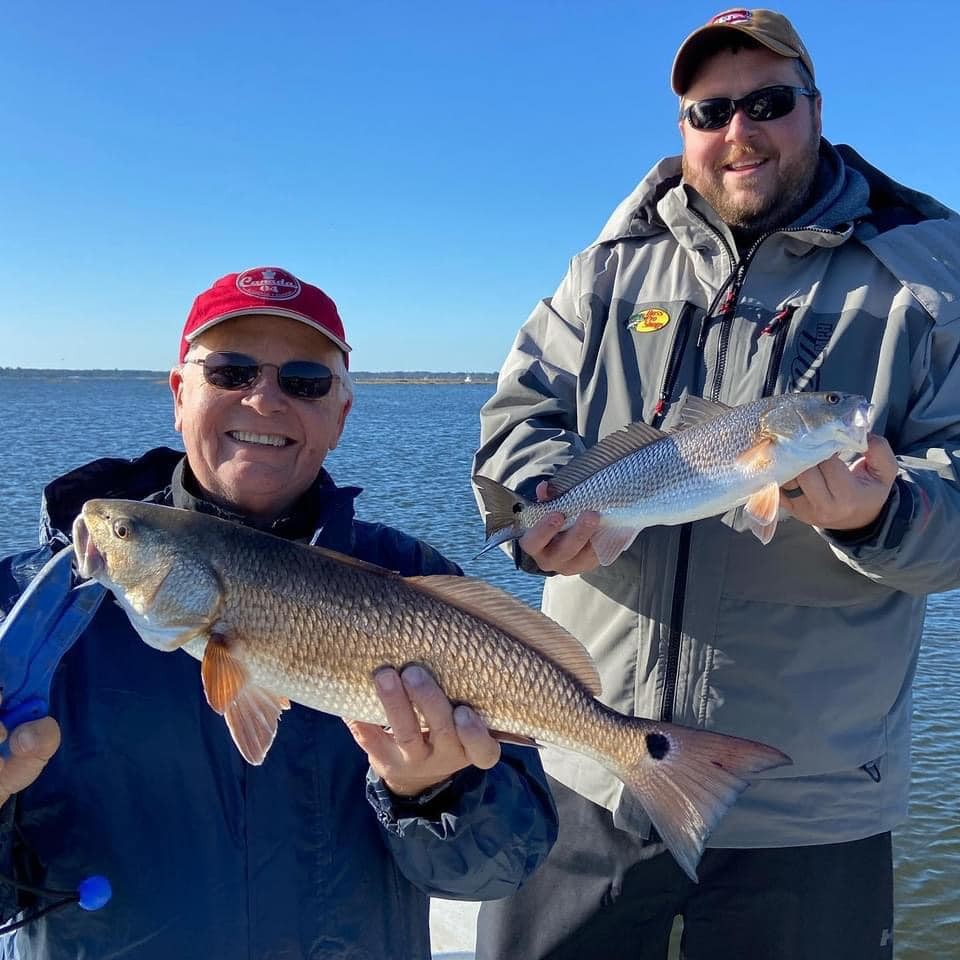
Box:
<box><xmin>73</xmin><ymin>500</ymin><xmax>790</xmax><ymax>877</ymax></box>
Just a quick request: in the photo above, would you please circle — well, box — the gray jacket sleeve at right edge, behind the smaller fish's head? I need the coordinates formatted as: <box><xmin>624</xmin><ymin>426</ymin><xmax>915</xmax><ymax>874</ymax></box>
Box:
<box><xmin>824</xmin><ymin>308</ymin><xmax>960</xmax><ymax>595</ymax></box>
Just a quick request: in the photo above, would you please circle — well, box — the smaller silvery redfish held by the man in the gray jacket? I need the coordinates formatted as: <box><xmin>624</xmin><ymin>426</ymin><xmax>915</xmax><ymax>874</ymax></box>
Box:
<box><xmin>473</xmin><ymin>393</ymin><xmax>870</xmax><ymax>566</ymax></box>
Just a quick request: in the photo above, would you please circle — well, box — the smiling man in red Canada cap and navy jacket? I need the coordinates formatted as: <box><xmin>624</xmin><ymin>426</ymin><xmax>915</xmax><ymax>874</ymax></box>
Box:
<box><xmin>0</xmin><ymin>267</ymin><xmax>556</xmax><ymax>960</ymax></box>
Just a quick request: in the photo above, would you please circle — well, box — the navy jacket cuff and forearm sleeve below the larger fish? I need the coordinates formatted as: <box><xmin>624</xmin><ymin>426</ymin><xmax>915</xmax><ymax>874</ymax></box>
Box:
<box><xmin>367</xmin><ymin>745</ymin><xmax>557</xmax><ymax>900</ymax></box>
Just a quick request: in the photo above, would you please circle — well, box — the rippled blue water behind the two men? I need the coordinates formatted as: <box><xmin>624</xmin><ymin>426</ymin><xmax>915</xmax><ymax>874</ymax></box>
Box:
<box><xmin>0</xmin><ymin>378</ymin><xmax>960</xmax><ymax>960</ymax></box>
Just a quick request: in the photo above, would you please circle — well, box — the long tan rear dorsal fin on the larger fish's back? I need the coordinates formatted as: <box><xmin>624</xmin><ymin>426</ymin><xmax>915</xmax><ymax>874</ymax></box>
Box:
<box><xmin>404</xmin><ymin>576</ymin><xmax>601</xmax><ymax>696</ymax></box>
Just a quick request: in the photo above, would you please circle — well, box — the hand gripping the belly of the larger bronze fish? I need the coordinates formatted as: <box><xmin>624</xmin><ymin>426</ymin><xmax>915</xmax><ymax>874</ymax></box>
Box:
<box><xmin>345</xmin><ymin>666</ymin><xmax>500</xmax><ymax>797</ymax></box>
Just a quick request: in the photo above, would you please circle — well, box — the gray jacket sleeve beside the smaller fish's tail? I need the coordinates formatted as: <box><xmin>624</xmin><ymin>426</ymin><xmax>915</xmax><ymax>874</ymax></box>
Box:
<box><xmin>473</xmin><ymin>258</ymin><xmax>585</xmax><ymax>572</ymax></box>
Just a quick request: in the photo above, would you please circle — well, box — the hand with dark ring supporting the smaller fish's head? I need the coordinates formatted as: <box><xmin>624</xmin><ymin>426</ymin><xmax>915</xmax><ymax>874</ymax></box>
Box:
<box><xmin>780</xmin><ymin>433</ymin><xmax>899</xmax><ymax>530</ymax></box>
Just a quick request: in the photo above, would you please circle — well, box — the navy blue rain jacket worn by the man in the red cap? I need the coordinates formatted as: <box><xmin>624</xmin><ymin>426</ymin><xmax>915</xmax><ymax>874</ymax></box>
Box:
<box><xmin>0</xmin><ymin>448</ymin><xmax>556</xmax><ymax>960</ymax></box>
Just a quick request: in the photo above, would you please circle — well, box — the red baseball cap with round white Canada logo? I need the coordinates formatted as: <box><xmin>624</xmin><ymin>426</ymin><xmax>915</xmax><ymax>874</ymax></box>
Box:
<box><xmin>180</xmin><ymin>267</ymin><xmax>350</xmax><ymax>363</ymax></box>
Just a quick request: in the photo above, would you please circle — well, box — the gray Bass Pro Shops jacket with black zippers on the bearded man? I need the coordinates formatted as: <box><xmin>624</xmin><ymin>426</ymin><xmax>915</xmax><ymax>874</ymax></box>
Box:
<box><xmin>474</xmin><ymin>142</ymin><xmax>960</xmax><ymax>847</ymax></box>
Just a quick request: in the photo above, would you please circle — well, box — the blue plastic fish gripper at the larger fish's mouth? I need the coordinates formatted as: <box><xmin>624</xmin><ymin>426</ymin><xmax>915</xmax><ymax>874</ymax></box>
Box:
<box><xmin>0</xmin><ymin>549</ymin><xmax>107</xmax><ymax>757</ymax></box>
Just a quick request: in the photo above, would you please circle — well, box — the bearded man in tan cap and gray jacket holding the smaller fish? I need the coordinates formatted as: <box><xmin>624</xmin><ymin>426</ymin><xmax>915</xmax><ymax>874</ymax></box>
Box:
<box><xmin>474</xmin><ymin>9</ymin><xmax>960</xmax><ymax>960</ymax></box>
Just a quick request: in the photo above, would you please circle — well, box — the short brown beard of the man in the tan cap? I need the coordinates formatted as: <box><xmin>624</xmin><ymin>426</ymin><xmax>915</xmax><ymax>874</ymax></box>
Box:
<box><xmin>682</xmin><ymin>133</ymin><xmax>820</xmax><ymax>237</ymax></box>
